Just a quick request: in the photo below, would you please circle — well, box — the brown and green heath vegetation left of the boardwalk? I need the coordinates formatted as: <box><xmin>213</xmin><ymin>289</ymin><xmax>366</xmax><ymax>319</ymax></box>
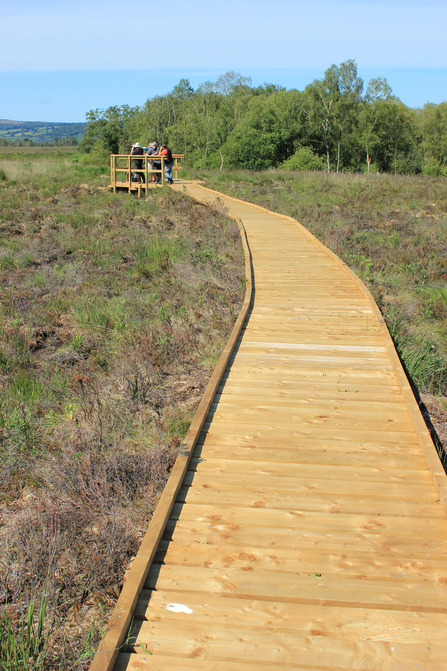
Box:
<box><xmin>0</xmin><ymin>157</ymin><xmax>244</xmax><ymax>669</ymax></box>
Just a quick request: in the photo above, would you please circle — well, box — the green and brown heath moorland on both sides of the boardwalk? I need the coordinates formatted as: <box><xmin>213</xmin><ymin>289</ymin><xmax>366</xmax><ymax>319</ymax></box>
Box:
<box><xmin>0</xmin><ymin>153</ymin><xmax>447</xmax><ymax>671</ymax></box>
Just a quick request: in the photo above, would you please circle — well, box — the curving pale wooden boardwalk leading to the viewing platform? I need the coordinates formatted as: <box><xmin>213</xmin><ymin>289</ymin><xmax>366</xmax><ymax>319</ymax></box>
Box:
<box><xmin>91</xmin><ymin>184</ymin><xmax>447</xmax><ymax>671</ymax></box>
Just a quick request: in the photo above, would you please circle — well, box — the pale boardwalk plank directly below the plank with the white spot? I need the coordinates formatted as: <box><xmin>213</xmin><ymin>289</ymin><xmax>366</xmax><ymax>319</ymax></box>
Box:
<box><xmin>123</xmin><ymin>621</ymin><xmax>447</xmax><ymax>671</ymax></box>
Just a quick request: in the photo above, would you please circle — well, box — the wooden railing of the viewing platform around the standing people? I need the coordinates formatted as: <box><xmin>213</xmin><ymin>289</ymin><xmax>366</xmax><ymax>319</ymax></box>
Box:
<box><xmin>109</xmin><ymin>154</ymin><xmax>185</xmax><ymax>195</ymax></box>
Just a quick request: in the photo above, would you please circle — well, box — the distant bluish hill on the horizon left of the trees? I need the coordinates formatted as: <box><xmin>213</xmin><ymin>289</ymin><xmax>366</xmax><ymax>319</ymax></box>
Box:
<box><xmin>0</xmin><ymin>119</ymin><xmax>87</xmax><ymax>142</ymax></box>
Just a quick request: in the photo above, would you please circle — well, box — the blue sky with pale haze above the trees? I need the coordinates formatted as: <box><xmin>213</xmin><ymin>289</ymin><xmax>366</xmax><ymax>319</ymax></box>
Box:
<box><xmin>0</xmin><ymin>0</ymin><xmax>447</xmax><ymax>122</ymax></box>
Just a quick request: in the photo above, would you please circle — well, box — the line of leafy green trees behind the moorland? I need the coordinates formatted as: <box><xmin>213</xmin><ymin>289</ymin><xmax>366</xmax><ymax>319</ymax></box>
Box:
<box><xmin>79</xmin><ymin>60</ymin><xmax>447</xmax><ymax>175</ymax></box>
